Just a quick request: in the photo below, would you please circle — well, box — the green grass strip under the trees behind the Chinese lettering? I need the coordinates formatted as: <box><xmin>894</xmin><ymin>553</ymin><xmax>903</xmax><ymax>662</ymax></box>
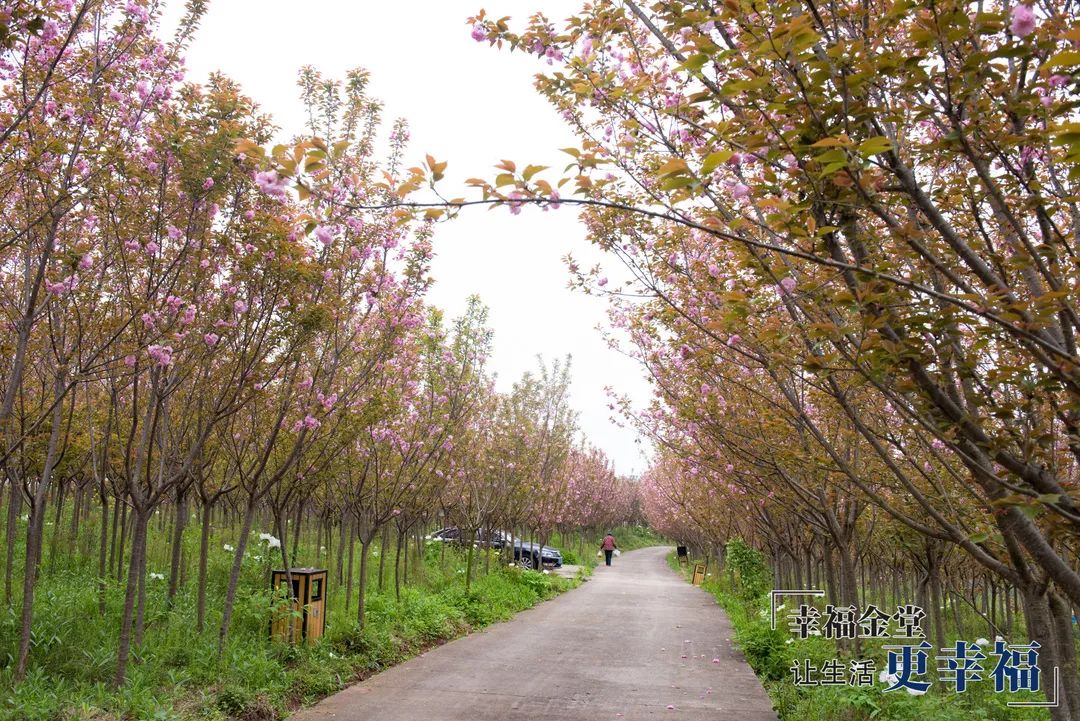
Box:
<box><xmin>669</xmin><ymin>553</ymin><xmax>1050</xmax><ymax>721</ymax></box>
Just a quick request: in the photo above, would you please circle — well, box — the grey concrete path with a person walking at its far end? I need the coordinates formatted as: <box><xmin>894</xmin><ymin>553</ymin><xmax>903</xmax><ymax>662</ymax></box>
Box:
<box><xmin>291</xmin><ymin>548</ymin><xmax>777</xmax><ymax>721</ymax></box>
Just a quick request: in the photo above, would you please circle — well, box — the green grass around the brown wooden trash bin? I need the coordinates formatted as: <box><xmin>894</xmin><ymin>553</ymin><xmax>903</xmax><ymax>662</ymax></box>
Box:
<box><xmin>0</xmin><ymin>515</ymin><xmax>576</xmax><ymax>721</ymax></box>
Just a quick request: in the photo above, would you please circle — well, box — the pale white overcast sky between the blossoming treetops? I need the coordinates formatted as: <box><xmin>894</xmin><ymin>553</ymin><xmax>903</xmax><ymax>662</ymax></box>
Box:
<box><xmin>162</xmin><ymin>0</ymin><xmax>649</xmax><ymax>474</ymax></box>
